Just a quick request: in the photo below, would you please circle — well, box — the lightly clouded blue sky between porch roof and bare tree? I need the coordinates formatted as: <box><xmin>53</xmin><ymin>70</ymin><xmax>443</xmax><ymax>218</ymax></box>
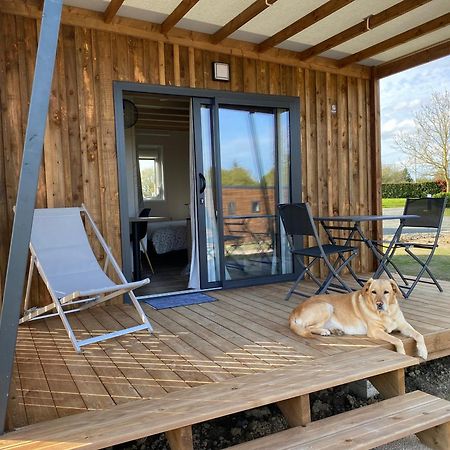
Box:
<box><xmin>380</xmin><ymin>56</ymin><xmax>450</xmax><ymax>166</ymax></box>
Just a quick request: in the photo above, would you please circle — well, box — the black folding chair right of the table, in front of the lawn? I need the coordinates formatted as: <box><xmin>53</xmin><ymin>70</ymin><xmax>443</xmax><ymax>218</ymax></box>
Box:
<box><xmin>374</xmin><ymin>197</ymin><xmax>447</xmax><ymax>298</ymax></box>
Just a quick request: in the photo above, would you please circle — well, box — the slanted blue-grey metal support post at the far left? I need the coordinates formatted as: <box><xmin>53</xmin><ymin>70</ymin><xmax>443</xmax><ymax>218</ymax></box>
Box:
<box><xmin>0</xmin><ymin>0</ymin><xmax>62</xmax><ymax>435</ymax></box>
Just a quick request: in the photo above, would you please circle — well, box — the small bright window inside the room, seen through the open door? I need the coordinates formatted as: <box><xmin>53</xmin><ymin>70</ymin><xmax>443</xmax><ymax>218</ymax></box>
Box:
<box><xmin>139</xmin><ymin>145</ymin><xmax>164</xmax><ymax>200</ymax></box>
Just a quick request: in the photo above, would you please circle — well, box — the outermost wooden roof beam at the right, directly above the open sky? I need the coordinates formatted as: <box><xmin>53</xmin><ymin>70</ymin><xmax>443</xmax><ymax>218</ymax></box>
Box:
<box><xmin>374</xmin><ymin>39</ymin><xmax>450</xmax><ymax>79</ymax></box>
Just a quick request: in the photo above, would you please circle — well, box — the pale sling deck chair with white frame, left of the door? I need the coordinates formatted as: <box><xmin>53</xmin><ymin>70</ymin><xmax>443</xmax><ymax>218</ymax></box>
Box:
<box><xmin>19</xmin><ymin>205</ymin><xmax>153</xmax><ymax>352</ymax></box>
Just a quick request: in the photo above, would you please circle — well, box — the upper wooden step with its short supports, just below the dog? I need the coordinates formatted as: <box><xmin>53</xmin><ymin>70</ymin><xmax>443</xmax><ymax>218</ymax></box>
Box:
<box><xmin>0</xmin><ymin>347</ymin><xmax>418</xmax><ymax>450</ymax></box>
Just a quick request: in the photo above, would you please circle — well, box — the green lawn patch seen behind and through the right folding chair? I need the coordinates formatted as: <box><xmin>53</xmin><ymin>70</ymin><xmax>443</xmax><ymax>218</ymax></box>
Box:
<box><xmin>394</xmin><ymin>242</ymin><xmax>450</xmax><ymax>281</ymax></box>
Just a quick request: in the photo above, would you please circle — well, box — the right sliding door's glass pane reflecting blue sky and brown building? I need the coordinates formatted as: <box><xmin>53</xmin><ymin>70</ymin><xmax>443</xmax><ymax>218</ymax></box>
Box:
<box><xmin>218</xmin><ymin>106</ymin><xmax>293</xmax><ymax>280</ymax></box>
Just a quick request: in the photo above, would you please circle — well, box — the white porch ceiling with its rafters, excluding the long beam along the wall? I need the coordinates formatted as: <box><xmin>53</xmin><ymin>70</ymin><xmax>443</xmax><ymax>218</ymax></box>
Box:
<box><xmin>65</xmin><ymin>0</ymin><xmax>450</xmax><ymax>77</ymax></box>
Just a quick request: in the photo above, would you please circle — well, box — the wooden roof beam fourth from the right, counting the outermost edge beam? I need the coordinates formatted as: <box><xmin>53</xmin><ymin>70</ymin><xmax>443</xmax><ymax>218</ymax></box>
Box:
<box><xmin>258</xmin><ymin>0</ymin><xmax>354</xmax><ymax>53</ymax></box>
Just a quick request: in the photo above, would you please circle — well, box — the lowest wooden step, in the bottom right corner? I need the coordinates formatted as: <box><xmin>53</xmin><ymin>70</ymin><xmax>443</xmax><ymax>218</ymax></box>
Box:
<box><xmin>230</xmin><ymin>391</ymin><xmax>450</xmax><ymax>450</ymax></box>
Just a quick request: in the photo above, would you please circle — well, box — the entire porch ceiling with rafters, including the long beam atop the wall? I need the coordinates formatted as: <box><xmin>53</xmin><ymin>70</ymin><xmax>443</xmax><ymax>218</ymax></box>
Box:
<box><xmin>4</xmin><ymin>0</ymin><xmax>450</xmax><ymax>78</ymax></box>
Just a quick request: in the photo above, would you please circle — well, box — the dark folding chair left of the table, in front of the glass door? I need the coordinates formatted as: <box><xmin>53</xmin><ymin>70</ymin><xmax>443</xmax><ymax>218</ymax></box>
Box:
<box><xmin>278</xmin><ymin>203</ymin><xmax>358</xmax><ymax>300</ymax></box>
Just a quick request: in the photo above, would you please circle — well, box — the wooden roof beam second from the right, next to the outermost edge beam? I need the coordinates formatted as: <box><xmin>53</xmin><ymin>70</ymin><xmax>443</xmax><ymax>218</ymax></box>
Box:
<box><xmin>339</xmin><ymin>13</ymin><xmax>450</xmax><ymax>67</ymax></box>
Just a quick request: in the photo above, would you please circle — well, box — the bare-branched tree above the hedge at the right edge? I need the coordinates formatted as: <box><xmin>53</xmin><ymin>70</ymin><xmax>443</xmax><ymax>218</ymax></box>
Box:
<box><xmin>395</xmin><ymin>90</ymin><xmax>450</xmax><ymax>192</ymax></box>
